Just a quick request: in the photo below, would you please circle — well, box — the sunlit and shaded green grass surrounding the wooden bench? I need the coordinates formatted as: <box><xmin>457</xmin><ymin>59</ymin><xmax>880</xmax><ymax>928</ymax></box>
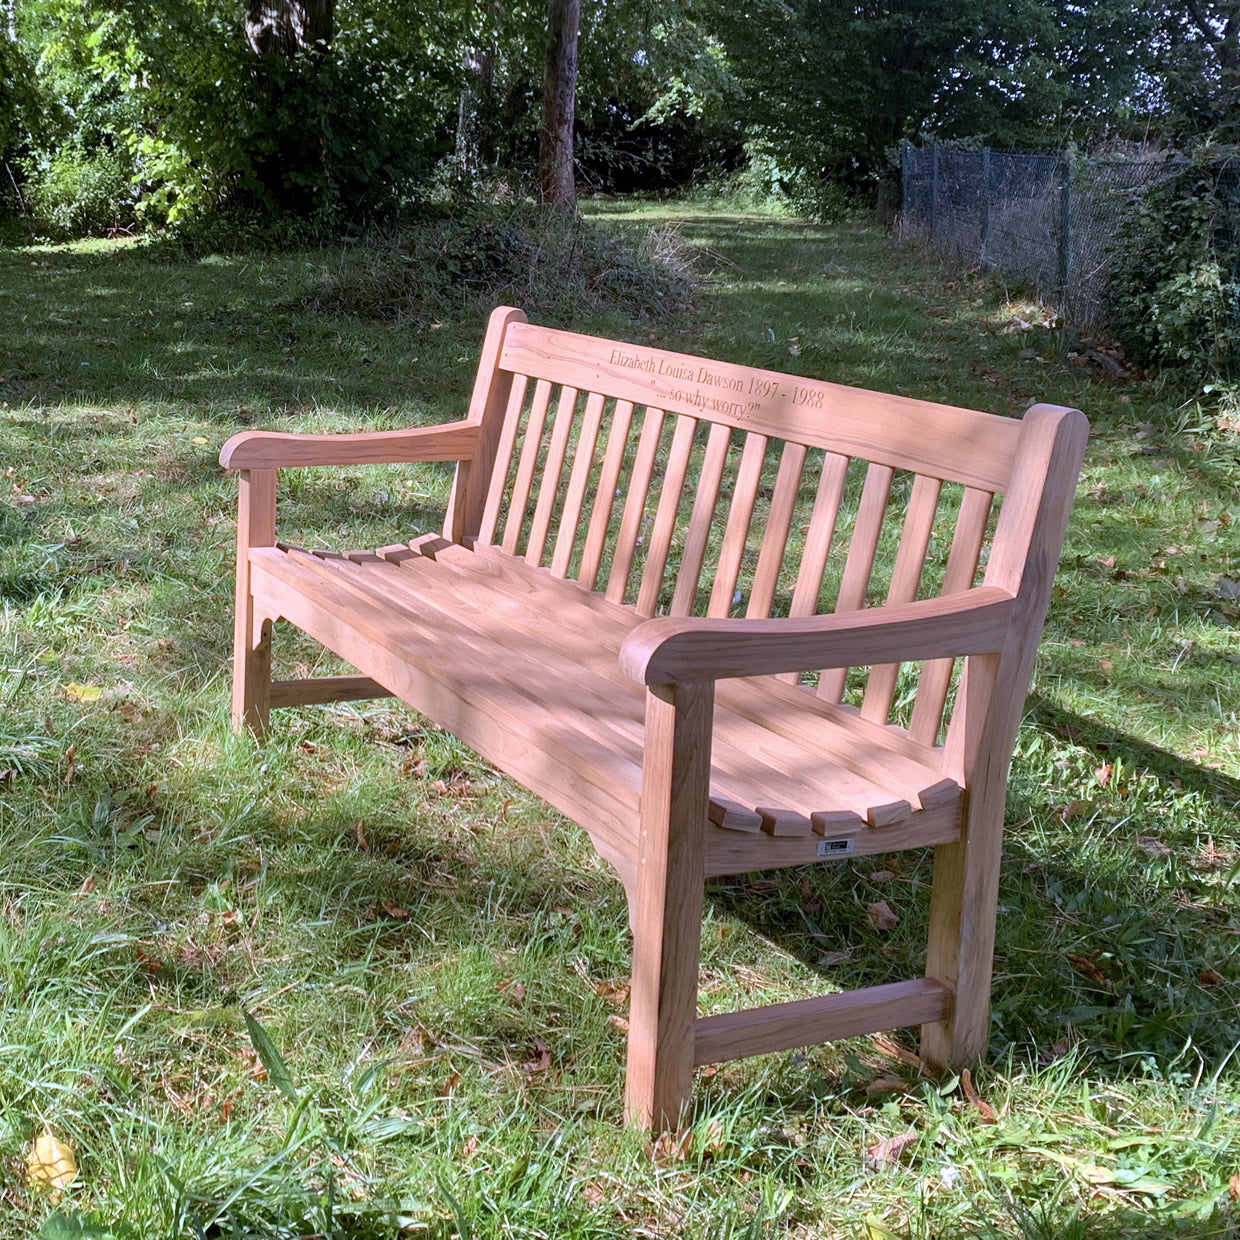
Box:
<box><xmin>0</xmin><ymin>205</ymin><xmax>1240</xmax><ymax>1240</ymax></box>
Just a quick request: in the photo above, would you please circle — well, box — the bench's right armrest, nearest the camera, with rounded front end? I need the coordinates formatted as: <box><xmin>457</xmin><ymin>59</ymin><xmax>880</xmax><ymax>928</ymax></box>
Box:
<box><xmin>620</xmin><ymin>585</ymin><xmax>1016</xmax><ymax>684</ymax></box>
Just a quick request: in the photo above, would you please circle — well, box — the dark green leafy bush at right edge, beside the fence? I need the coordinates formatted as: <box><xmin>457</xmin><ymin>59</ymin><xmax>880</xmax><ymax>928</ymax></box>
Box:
<box><xmin>1106</xmin><ymin>149</ymin><xmax>1240</xmax><ymax>377</ymax></box>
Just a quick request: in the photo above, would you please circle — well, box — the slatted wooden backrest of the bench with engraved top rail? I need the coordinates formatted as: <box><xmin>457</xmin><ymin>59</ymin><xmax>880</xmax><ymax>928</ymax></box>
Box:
<box><xmin>446</xmin><ymin>310</ymin><xmax>1084</xmax><ymax>763</ymax></box>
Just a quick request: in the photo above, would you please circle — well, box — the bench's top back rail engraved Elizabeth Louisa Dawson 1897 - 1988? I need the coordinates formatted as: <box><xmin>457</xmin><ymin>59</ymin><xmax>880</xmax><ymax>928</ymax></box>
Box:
<box><xmin>498</xmin><ymin>322</ymin><xmax>1021</xmax><ymax>492</ymax></box>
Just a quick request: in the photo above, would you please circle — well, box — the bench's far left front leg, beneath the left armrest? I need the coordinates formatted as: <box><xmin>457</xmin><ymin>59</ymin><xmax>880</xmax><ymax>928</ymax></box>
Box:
<box><xmin>232</xmin><ymin>469</ymin><xmax>275</xmax><ymax>737</ymax></box>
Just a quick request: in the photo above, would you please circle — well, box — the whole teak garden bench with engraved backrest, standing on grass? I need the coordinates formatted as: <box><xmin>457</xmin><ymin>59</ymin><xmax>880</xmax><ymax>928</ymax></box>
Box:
<box><xmin>221</xmin><ymin>309</ymin><xmax>1087</xmax><ymax>1126</ymax></box>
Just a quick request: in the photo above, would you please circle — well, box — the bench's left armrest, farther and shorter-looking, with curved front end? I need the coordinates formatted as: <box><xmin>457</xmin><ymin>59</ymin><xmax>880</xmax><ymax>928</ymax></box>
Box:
<box><xmin>219</xmin><ymin>422</ymin><xmax>479</xmax><ymax>469</ymax></box>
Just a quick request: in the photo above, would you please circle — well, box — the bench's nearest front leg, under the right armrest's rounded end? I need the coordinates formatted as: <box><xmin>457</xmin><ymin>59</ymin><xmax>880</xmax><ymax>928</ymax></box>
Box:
<box><xmin>625</xmin><ymin>683</ymin><xmax>714</xmax><ymax>1130</ymax></box>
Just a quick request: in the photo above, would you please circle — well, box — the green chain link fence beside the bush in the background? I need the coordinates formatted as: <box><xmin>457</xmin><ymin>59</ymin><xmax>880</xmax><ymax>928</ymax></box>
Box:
<box><xmin>899</xmin><ymin>143</ymin><xmax>1184</xmax><ymax>329</ymax></box>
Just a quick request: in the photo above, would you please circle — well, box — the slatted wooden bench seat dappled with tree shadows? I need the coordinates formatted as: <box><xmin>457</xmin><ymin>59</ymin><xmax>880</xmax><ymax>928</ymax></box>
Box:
<box><xmin>250</xmin><ymin>536</ymin><xmax>962</xmax><ymax>880</ymax></box>
